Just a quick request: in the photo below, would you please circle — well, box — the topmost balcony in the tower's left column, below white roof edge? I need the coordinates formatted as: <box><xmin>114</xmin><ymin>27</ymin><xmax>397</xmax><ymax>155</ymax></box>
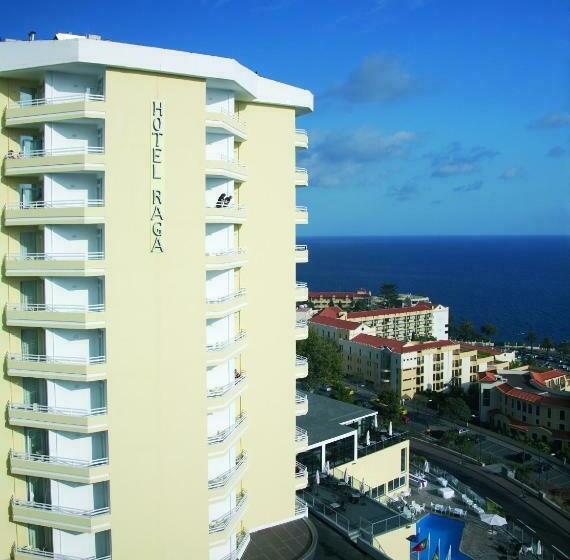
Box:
<box><xmin>5</xmin><ymin>93</ymin><xmax>105</xmax><ymax>127</ymax></box>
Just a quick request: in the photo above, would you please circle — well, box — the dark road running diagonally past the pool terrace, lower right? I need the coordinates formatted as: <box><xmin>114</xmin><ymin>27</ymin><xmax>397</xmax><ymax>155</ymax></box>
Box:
<box><xmin>410</xmin><ymin>440</ymin><xmax>570</xmax><ymax>554</ymax></box>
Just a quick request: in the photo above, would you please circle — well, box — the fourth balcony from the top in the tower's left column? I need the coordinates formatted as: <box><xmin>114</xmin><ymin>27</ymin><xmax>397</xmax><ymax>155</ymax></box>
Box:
<box><xmin>5</xmin><ymin>252</ymin><xmax>105</xmax><ymax>276</ymax></box>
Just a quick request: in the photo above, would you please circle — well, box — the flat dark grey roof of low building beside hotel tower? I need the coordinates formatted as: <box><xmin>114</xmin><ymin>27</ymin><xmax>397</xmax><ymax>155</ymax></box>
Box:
<box><xmin>297</xmin><ymin>393</ymin><xmax>377</xmax><ymax>446</ymax></box>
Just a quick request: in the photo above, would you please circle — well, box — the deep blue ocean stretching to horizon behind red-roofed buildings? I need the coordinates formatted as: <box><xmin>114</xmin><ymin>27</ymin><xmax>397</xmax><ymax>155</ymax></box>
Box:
<box><xmin>297</xmin><ymin>236</ymin><xmax>570</xmax><ymax>342</ymax></box>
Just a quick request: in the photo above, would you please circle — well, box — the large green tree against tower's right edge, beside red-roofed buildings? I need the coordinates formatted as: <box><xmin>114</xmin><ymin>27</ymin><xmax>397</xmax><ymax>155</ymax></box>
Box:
<box><xmin>297</xmin><ymin>329</ymin><xmax>343</xmax><ymax>389</ymax></box>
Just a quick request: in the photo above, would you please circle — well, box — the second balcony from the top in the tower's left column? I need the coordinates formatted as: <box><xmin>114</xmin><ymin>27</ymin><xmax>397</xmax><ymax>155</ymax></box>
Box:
<box><xmin>4</xmin><ymin>146</ymin><xmax>105</xmax><ymax>177</ymax></box>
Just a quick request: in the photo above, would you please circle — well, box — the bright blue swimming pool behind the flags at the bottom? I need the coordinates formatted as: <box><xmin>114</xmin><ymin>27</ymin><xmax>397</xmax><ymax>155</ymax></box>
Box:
<box><xmin>410</xmin><ymin>513</ymin><xmax>472</xmax><ymax>560</ymax></box>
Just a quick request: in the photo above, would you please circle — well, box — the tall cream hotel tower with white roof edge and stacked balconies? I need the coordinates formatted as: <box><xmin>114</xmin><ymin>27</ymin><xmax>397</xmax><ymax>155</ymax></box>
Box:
<box><xmin>0</xmin><ymin>35</ymin><xmax>313</xmax><ymax>560</ymax></box>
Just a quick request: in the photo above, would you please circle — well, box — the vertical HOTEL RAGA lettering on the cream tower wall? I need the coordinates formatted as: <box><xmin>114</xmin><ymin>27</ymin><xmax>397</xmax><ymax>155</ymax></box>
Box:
<box><xmin>150</xmin><ymin>100</ymin><xmax>165</xmax><ymax>253</ymax></box>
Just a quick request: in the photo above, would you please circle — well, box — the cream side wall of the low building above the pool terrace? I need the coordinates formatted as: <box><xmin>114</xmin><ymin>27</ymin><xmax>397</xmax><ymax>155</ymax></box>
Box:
<box><xmin>338</xmin><ymin>440</ymin><xmax>410</xmax><ymax>492</ymax></box>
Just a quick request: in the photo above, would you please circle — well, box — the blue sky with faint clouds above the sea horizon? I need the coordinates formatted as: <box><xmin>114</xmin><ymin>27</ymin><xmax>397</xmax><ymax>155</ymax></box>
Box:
<box><xmin>5</xmin><ymin>0</ymin><xmax>570</xmax><ymax>235</ymax></box>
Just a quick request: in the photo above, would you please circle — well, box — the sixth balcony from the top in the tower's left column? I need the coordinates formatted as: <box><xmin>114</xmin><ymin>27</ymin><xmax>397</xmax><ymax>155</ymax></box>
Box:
<box><xmin>6</xmin><ymin>353</ymin><xmax>107</xmax><ymax>381</ymax></box>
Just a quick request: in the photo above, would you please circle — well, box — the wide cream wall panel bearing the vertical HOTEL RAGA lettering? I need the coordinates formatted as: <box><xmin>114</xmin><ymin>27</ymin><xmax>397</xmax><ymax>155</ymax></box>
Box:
<box><xmin>105</xmin><ymin>69</ymin><xmax>208</xmax><ymax>560</ymax></box>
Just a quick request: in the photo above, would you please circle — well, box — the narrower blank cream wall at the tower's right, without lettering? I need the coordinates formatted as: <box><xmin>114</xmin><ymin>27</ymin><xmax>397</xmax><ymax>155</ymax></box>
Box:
<box><xmin>239</xmin><ymin>100</ymin><xmax>295</xmax><ymax>529</ymax></box>
